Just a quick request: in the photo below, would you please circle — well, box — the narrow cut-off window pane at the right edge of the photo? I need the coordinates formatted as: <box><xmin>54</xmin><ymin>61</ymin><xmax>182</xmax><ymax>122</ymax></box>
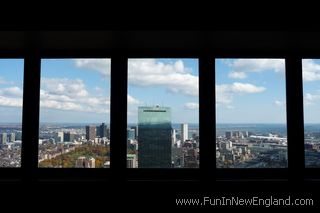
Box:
<box><xmin>302</xmin><ymin>59</ymin><xmax>320</xmax><ymax>168</ymax></box>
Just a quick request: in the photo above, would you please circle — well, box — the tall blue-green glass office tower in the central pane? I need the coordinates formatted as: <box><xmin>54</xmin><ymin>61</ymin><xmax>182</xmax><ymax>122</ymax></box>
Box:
<box><xmin>138</xmin><ymin>106</ymin><xmax>172</xmax><ymax>168</ymax></box>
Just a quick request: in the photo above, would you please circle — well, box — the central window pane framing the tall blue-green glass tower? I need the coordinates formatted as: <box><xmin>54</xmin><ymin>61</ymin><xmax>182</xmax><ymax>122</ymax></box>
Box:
<box><xmin>127</xmin><ymin>59</ymin><xmax>199</xmax><ymax>168</ymax></box>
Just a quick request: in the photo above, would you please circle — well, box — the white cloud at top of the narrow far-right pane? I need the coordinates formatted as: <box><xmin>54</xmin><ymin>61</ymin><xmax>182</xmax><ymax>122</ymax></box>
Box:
<box><xmin>302</xmin><ymin>59</ymin><xmax>320</xmax><ymax>81</ymax></box>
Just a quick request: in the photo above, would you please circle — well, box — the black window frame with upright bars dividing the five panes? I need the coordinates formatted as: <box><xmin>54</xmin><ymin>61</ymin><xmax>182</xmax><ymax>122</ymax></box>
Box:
<box><xmin>0</xmin><ymin>30</ymin><xmax>320</xmax><ymax>182</ymax></box>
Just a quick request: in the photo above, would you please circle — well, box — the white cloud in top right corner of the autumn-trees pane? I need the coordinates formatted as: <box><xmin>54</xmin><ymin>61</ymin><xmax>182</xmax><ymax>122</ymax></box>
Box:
<box><xmin>74</xmin><ymin>59</ymin><xmax>111</xmax><ymax>77</ymax></box>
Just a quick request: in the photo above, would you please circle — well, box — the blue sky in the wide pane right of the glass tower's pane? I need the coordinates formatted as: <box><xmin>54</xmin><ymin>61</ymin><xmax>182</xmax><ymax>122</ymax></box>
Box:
<box><xmin>216</xmin><ymin>59</ymin><xmax>286</xmax><ymax>123</ymax></box>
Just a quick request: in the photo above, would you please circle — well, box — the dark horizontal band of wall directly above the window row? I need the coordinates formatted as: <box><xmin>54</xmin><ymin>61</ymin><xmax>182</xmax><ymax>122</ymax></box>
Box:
<box><xmin>0</xmin><ymin>30</ymin><xmax>320</xmax><ymax>57</ymax></box>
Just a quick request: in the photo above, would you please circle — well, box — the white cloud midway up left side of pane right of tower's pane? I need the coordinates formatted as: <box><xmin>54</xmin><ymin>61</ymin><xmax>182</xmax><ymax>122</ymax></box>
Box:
<box><xmin>216</xmin><ymin>82</ymin><xmax>266</xmax><ymax>108</ymax></box>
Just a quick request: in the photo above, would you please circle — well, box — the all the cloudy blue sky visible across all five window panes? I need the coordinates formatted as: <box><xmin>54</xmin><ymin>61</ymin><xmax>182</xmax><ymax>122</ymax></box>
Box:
<box><xmin>0</xmin><ymin>59</ymin><xmax>320</xmax><ymax>123</ymax></box>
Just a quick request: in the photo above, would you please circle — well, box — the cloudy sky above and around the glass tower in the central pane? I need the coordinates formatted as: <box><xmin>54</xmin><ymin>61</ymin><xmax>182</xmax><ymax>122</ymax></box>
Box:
<box><xmin>127</xmin><ymin>59</ymin><xmax>199</xmax><ymax>124</ymax></box>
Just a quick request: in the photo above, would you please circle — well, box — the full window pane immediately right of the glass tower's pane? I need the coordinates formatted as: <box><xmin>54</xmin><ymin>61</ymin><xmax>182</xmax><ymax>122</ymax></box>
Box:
<box><xmin>216</xmin><ymin>59</ymin><xmax>287</xmax><ymax>168</ymax></box>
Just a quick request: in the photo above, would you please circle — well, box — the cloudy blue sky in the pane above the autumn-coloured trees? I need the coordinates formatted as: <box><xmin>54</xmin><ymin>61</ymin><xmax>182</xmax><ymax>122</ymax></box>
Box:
<box><xmin>40</xmin><ymin>59</ymin><xmax>110</xmax><ymax>123</ymax></box>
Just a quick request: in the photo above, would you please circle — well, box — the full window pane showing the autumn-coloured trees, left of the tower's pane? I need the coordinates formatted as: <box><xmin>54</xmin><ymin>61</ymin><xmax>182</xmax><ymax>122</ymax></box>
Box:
<box><xmin>39</xmin><ymin>59</ymin><xmax>110</xmax><ymax>168</ymax></box>
